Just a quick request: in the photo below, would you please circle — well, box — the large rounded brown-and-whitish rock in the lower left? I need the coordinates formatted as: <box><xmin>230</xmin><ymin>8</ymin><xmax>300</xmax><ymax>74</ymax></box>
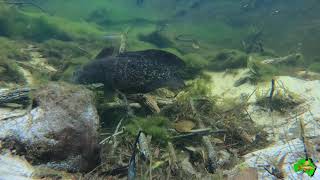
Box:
<box><xmin>0</xmin><ymin>83</ymin><xmax>99</xmax><ymax>171</ymax></box>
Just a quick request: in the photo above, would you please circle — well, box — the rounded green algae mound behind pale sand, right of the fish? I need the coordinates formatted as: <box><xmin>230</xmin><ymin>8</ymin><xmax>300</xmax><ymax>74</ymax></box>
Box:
<box><xmin>209</xmin><ymin>50</ymin><xmax>248</xmax><ymax>71</ymax></box>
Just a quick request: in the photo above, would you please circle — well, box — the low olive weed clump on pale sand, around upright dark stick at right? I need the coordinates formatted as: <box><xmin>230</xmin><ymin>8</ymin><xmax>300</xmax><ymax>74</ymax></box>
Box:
<box><xmin>256</xmin><ymin>85</ymin><xmax>303</xmax><ymax>113</ymax></box>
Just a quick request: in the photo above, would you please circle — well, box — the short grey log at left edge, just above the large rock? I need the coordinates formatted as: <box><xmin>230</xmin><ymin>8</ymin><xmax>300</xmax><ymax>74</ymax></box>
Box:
<box><xmin>0</xmin><ymin>88</ymin><xmax>31</xmax><ymax>105</ymax></box>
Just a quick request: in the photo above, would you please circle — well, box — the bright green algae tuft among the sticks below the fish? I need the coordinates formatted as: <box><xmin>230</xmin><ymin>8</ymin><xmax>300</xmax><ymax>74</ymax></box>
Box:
<box><xmin>126</xmin><ymin>116</ymin><xmax>169</xmax><ymax>143</ymax></box>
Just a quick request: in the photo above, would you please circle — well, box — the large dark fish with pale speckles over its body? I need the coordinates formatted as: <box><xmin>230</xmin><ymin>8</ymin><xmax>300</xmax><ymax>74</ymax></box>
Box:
<box><xmin>76</xmin><ymin>50</ymin><xmax>184</xmax><ymax>93</ymax></box>
